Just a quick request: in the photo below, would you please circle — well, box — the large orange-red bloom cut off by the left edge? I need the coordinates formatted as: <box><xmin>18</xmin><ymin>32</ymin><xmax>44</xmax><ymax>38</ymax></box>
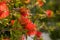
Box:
<box><xmin>0</xmin><ymin>2</ymin><xmax>9</xmax><ymax>19</ymax></box>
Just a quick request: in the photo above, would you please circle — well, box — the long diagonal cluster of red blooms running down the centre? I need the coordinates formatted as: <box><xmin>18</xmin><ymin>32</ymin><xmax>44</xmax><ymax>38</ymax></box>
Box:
<box><xmin>19</xmin><ymin>7</ymin><xmax>37</xmax><ymax>35</ymax></box>
